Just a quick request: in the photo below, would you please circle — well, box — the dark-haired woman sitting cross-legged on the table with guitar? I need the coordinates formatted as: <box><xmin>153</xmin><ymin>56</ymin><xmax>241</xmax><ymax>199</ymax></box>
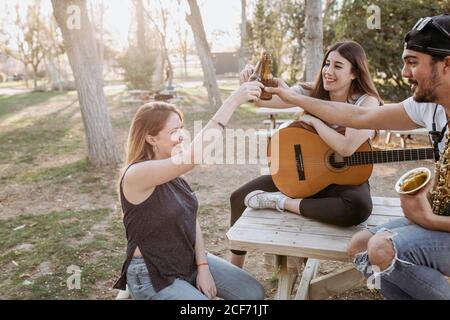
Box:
<box><xmin>230</xmin><ymin>41</ymin><xmax>382</xmax><ymax>267</ymax></box>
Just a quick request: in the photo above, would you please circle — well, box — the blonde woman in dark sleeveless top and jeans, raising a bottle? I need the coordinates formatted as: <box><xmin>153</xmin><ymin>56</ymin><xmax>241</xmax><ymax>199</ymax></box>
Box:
<box><xmin>114</xmin><ymin>82</ymin><xmax>264</xmax><ymax>300</ymax></box>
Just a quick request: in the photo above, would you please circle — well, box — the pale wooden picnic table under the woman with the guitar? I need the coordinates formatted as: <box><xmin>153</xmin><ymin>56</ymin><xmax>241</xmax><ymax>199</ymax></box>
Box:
<box><xmin>227</xmin><ymin>197</ymin><xmax>403</xmax><ymax>300</ymax></box>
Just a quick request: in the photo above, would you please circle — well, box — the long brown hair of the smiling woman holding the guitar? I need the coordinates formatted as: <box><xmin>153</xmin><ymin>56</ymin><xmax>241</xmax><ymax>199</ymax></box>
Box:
<box><xmin>302</xmin><ymin>41</ymin><xmax>383</xmax><ymax>103</ymax></box>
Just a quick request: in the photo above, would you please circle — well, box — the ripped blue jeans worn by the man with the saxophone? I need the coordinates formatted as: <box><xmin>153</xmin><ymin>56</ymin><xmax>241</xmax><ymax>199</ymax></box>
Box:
<box><xmin>354</xmin><ymin>218</ymin><xmax>450</xmax><ymax>300</ymax></box>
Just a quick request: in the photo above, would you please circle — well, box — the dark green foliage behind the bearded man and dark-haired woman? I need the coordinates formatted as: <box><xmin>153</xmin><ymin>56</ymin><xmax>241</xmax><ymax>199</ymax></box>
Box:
<box><xmin>324</xmin><ymin>0</ymin><xmax>450</xmax><ymax>101</ymax></box>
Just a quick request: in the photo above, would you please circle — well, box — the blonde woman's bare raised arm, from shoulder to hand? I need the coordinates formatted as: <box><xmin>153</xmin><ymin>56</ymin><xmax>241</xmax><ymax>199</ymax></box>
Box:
<box><xmin>124</xmin><ymin>82</ymin><xmax>263</xmax><ymax>192</ymax></box>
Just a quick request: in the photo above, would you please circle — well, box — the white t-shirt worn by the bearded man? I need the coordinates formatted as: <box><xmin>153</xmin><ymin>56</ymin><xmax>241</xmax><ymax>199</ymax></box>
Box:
<box><xmin>403</xmin><ymin>97</ymin><xmax>447</xmax><ymax>152</ymax></box>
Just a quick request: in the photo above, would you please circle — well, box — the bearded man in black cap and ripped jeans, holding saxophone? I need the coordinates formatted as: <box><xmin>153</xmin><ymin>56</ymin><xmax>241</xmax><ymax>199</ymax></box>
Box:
<box><xmin>265</xmin><ymin>14</ymin><xmax>450</xmax><ymax>299</ymax></box>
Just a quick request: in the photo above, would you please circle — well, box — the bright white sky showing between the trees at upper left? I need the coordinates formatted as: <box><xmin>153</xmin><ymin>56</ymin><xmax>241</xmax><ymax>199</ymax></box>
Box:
<box><xmin>0</xmin><ymin>0</ymin><xmax>246</xmax><ymax>52</ymax></box>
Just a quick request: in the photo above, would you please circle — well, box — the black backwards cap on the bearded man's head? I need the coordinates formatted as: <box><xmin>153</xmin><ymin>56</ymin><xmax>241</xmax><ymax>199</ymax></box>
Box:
<box><xmin>405</xmin><ymin>13</ymin><xmax>450</xmax><ymax>57</ymax></box>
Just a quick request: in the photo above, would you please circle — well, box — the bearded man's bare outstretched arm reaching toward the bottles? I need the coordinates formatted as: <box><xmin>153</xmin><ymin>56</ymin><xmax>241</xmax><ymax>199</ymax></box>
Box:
<box><xmin>265</xmin><ymin>79</ymin><xmax>419</xmax><ymax>130</ymax></box>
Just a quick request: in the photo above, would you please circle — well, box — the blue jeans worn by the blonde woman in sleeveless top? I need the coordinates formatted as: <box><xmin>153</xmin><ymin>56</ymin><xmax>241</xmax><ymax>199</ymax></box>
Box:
<box><xmin>127</xmin><ymin>253</ymin><xmax>265</xmax><ymax>300</ymax></box>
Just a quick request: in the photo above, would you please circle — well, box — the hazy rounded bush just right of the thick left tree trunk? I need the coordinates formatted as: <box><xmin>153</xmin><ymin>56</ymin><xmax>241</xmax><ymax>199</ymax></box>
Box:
<box><xmin>117</xmin><ymin>47</ymin><xmax>156</xmax><ymax>90</ymax></box>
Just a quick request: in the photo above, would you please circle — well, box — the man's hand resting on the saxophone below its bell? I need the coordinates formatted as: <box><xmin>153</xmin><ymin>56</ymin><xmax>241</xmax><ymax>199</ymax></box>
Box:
<box><xmin>400</xmin><ymin>181</ymin><xmax>435</xmax><ymax>229</ymax></box>
